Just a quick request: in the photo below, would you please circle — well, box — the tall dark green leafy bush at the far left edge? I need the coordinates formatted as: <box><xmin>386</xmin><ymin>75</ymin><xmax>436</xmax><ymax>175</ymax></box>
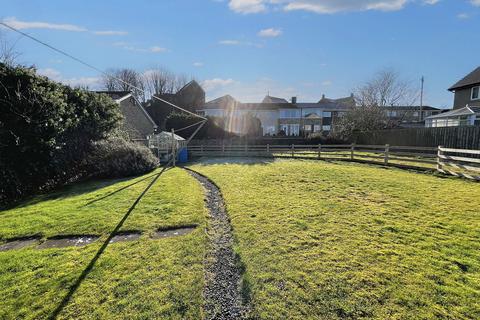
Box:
<box><xmin>0</xmin><ymin>63</ymin><xmax>122</xmax><ymax>204</ymax></box>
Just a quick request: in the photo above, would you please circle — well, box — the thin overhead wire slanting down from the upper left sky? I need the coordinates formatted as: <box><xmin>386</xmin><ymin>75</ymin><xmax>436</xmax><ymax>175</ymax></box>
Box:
<box><xmin>0</xmin><ymin>21</ymin><xmax>207</xmax><ymax>121</ymax></box>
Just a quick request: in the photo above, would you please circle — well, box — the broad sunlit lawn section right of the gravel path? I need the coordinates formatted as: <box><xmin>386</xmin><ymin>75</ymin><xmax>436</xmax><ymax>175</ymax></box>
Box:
<box><xmin>192</xmin><ymin>160</ymin><xmax>480</xmax><ymax>319</ymax></box>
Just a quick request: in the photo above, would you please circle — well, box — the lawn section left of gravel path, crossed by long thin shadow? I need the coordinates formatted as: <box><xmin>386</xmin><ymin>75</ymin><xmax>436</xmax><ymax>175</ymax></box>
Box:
<box><xmin>0</xmin><ymin>169</ymin><xmax>206</xmax><ymax>319</ymax></box>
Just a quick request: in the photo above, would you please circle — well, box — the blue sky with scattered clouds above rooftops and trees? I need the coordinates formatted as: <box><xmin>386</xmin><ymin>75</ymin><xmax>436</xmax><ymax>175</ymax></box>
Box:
<box><xmin>0</xmin><ymin>0</ymin><xmax>480</xmax><ymax>107</ymax></box>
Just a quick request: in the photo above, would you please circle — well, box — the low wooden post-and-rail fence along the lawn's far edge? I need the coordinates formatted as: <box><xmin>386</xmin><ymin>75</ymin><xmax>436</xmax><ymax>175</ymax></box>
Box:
<box><xmin>188</xmin><ymin>144</ymin><xmax>480</xmax><ymax>180</ymax></box>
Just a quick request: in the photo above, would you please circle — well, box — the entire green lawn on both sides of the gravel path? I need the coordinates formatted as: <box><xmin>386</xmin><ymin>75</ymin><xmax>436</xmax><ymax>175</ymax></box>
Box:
<box><xmin>0</xmin><ymin>159</ymin><xmax>480</xmax><ymax>319</ymax></box>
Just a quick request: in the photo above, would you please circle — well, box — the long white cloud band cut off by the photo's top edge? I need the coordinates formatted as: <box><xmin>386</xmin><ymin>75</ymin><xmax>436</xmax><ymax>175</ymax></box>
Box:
<box><xmin>229</xmin><ymin>0</ymin><xmax>440</xmax><ymax>14</ymax></box>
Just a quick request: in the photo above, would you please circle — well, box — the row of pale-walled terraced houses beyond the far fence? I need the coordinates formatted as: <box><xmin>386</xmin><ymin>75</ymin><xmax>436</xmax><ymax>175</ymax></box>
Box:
<box><xmin>197</xmin><ymin>95</ymin><xmax>355</xmax><ymax>136</ymax></box>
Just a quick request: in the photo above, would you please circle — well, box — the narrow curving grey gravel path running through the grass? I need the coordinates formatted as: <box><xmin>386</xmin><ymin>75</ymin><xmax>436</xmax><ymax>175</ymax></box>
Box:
<box><xmin>189</xmin><ymin>170</ymin><xmax>248</xmax><ymax>319</ymax></box>
